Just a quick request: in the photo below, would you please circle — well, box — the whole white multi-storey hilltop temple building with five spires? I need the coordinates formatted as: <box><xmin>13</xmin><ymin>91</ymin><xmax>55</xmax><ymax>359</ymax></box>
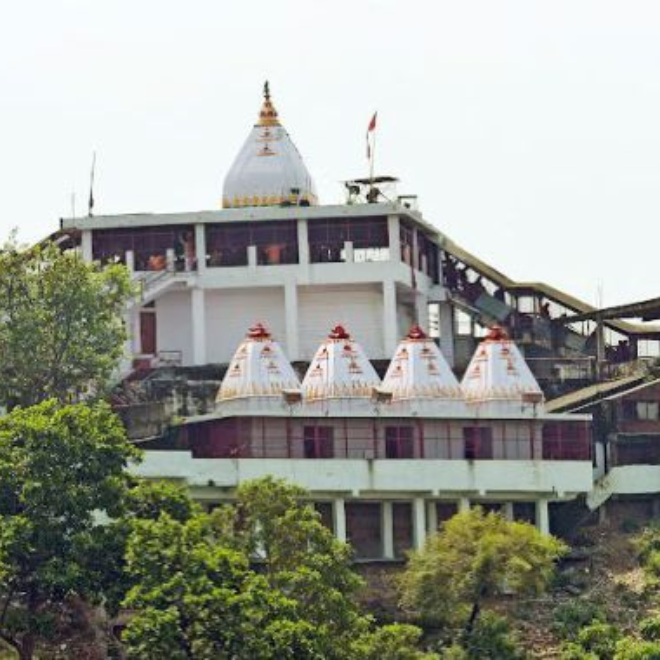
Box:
<box><xmin>61</xmin><ymin>86</ymin><xmax>660</xmax><ymax>560</ymax></box>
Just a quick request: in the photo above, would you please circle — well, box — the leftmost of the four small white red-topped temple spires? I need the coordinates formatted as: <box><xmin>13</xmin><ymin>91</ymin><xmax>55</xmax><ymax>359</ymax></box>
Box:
<box><xmin>216</xmin><ymin>323</ymin><xmax>300</xmax><ymax>414</ymax></box>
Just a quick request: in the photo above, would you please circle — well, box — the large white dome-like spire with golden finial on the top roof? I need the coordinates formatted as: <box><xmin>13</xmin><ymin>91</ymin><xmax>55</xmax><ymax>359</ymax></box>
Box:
<box><xmin>222</xmin><ymin>83</ymin><xmax>317</xmax><ymax>208</ymax></box>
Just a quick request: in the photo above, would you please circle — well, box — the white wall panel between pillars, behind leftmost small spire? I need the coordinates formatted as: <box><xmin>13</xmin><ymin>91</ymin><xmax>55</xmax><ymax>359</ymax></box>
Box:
<box><xmin>206</xmin><ymin>287</ymin><xmax>288</xmax><ymax>363</ymax></box>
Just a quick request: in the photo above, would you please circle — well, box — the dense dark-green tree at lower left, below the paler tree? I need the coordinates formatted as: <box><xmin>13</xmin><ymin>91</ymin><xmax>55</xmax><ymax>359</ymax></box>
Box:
<box><xmin>0</xmin><ymin>401</ymin><xmax>139</xmax><ymax>659</ymax></box>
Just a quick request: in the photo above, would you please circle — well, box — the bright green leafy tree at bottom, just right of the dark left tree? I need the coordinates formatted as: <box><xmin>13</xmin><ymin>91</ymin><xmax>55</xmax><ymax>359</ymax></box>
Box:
<box><xmin>123</xmin><ymin>513</ymin><xmax>325</xmax><ymax>660</ymax></box>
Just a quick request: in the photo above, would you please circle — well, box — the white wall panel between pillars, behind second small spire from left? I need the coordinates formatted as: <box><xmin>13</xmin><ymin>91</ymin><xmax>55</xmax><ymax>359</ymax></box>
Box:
<box><xmin>298</xmin><ymin>285</ymin><xmax>384</xmax><ymax>360</ymax></box>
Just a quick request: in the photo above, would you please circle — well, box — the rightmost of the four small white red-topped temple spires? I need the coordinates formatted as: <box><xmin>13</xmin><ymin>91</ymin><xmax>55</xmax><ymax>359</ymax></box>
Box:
<box><xmin>461</xmin><ymin>326</ymin><xmax>544</xmax><ymax>417</ymax></box>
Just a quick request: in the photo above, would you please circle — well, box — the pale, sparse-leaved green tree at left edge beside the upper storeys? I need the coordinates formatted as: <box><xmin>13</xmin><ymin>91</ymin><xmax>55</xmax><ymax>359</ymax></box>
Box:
<box><xmin>0</xmin><ymin>242</ymin><xmax>132</xmax><ymax>408</ymax></box>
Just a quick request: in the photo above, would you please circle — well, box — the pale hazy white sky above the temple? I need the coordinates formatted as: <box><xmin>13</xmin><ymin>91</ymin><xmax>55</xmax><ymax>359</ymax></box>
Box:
<box><xmin>0</xmin><ymin>0</ymin><xmax>660</xmax><ymax>304</ymax></box>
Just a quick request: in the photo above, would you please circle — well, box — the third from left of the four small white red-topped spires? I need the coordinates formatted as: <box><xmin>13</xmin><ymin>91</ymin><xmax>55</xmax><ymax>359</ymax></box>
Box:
<box><xmin>380</xmin><ymin>325</ymin><xmax>466</xmax><ymax>415</ymax></box>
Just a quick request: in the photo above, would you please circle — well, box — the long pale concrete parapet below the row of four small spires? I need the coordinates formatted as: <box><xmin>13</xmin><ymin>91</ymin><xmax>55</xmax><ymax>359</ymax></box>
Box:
<box><xmin>135</xmin><ymin>451</ymin><xmax>592</xmax><ymax>499</ymax></box>
